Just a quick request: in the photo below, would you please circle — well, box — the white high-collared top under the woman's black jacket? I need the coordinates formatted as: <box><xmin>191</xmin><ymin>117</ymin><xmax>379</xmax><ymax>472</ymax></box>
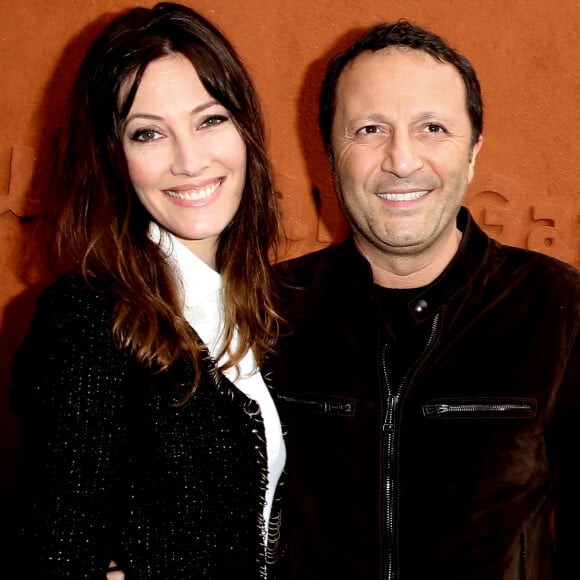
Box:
<box><xmin>149</xmin><ymin>224</ymin><xmax>286</xmax><ymax>533</ymax></box>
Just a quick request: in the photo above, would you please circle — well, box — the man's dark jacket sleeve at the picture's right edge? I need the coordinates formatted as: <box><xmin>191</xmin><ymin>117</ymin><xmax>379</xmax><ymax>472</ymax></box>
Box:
<box><xmin>553</xmin><ymin>324</ymin><xmax>580</xmax><ymax>580</ymax></box>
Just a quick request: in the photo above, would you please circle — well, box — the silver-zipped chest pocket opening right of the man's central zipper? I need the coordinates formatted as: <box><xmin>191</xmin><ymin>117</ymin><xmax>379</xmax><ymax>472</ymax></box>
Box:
<box><xmin>422</xmin><ymin>397</ymin><xmax>537</xmax><ymax>420</ymax></box>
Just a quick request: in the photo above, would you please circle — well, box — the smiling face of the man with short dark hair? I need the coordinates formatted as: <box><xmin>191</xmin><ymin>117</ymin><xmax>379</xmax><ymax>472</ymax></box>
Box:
<box><xmin>331</xmin><ymin>48</ymin><xmax>481</xmax><ymax>256</ymax></box>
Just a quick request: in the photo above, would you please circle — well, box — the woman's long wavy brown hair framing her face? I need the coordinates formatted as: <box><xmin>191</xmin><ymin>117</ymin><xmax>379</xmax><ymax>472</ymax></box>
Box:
<box><xmin>49</xmin><ymin>3</ymin><xmax>281</xmax><ymax>400</ymax></box>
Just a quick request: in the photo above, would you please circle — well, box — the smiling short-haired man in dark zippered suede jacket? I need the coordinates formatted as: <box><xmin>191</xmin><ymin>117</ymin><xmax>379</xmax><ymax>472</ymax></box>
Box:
<box><xmin>273</xmin><ymin>21</ymin><xmax>580</xmax><ymax>580</ymax></box>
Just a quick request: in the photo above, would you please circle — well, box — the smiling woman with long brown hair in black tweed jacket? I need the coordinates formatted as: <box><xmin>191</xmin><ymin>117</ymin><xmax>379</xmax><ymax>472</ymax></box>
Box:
<box><xmin>13</xmin><ymin>3</ymin><xmax>285</xmax><ymax>580</ymax></box>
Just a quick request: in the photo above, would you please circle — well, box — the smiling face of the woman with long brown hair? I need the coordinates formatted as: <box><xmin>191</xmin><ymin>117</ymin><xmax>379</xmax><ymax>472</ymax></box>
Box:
<box><xmin>122</xmin><ymin>53</ymin><xmax>246</xmax><ymax>266</ymax></box>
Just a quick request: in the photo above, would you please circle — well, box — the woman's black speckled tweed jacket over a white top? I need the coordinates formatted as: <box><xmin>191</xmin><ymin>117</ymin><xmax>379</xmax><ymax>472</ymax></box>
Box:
<box><xmin>13</xmin><ymin>278</ymin><xmax>279</xmax><ymax>580</ymax></box>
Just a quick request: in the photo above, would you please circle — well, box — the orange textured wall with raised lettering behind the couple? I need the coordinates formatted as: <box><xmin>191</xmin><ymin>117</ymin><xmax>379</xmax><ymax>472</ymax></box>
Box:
<box><xmin>0</xmin><ymin>0</ymin><xmax>580</xmax><ymax>512</ymax></box>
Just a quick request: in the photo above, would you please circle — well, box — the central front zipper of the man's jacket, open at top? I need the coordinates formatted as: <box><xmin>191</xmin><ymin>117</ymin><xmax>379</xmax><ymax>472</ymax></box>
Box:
<box><xmin>381</xmin><ymin>314</ymin><xmax>440</xmax><ymax>580</ymax></box>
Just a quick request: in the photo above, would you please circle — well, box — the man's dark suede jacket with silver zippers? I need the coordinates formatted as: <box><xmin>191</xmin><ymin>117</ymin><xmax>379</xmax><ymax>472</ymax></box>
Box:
<box><xmin>272</xmin><ymin>208</ymin><xmax>580</xmax><ymax>580</ymax></box>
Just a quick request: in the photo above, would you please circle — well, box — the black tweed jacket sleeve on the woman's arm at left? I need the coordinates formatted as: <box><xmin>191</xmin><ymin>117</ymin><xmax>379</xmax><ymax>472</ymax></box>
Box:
<box><xmin>12</xmin><ymin>285</ymin><xmax>134</xmax><ymax>580</ymax></box>
